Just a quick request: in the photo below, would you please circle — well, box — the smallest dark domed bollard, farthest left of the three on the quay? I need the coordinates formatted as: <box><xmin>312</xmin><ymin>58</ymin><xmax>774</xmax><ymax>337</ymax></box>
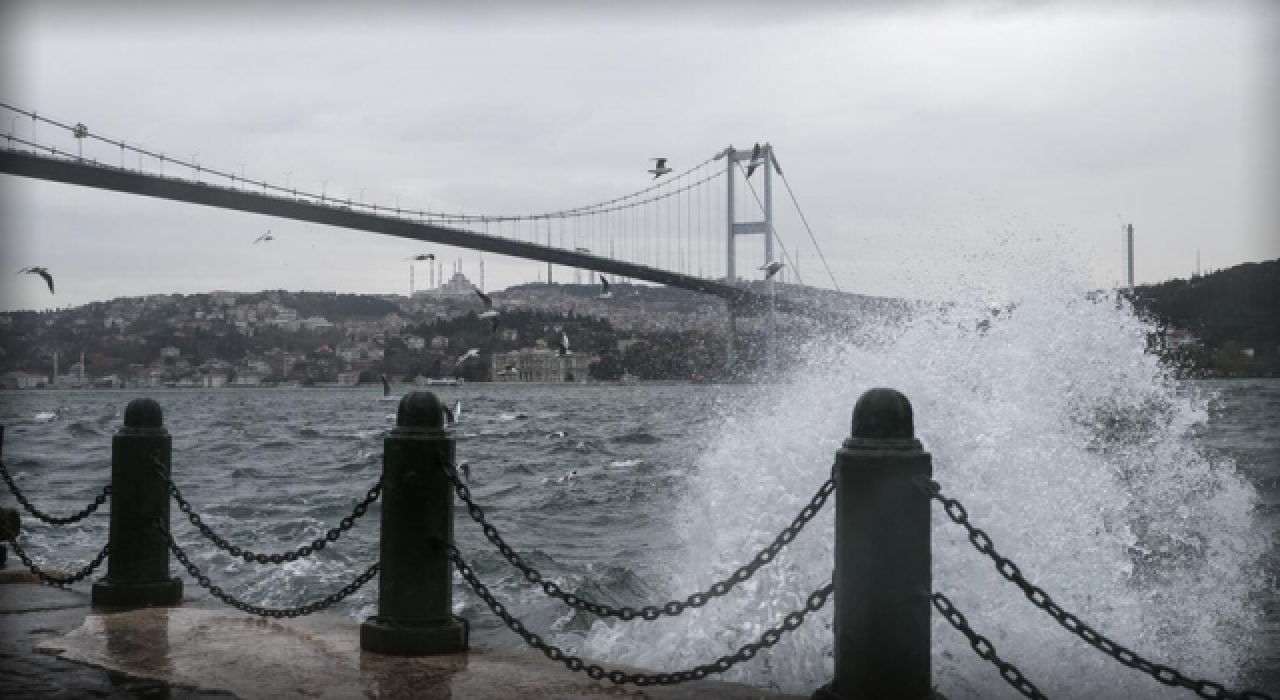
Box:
<box><xmin>92</xmin><ymin>398</ymin><xmax>182</xmax><ymax>607</ymax></box>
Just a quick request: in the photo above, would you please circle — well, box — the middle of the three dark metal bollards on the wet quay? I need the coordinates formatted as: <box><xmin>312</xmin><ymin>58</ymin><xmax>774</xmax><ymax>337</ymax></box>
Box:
<box><xmin>360</xmin><ymin>392</ymin><xmax>468</xmax><ymax>656</ymax></box>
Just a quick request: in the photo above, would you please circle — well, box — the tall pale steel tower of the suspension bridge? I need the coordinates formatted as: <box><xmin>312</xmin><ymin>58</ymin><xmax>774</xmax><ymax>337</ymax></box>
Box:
<box><xmin>718</xmin><ymin>143</ymin><xmax>777</xmax><ymax>372</ymax></box>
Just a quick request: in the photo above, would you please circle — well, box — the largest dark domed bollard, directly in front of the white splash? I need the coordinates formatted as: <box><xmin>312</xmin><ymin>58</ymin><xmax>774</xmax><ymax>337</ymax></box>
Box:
<box><xmin>814</xmin><ymin>389</ymin><xmax>933</xmax><ymax>700</ymax></box>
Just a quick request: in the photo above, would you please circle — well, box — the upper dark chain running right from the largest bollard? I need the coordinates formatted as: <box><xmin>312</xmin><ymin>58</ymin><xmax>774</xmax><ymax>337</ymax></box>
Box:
<box><xmin>915</xmin><ymin>477</ymin><xmax>1272</xmax><ymax>700</ymax></box>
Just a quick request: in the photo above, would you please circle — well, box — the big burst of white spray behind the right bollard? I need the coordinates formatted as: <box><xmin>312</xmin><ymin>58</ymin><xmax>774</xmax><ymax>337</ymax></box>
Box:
<box><xmin>570</xmin><ymin>272</ymin><xmax>1270</xmax><ymax>700</ymax></box>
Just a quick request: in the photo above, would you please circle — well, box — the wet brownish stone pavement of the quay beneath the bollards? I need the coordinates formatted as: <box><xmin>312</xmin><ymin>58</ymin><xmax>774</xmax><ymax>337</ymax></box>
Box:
<box><xmin>0</xmin><ymin>584</ymin><xmax>799</xmax><ymax>700</ymax></box>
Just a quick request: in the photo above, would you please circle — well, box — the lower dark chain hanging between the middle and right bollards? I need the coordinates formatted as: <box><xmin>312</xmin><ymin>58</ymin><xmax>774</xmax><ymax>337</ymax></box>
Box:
<box><xmin>448</xmin><ymin>544</ymin><xmax>836</xmax><ymax>686</ymax></box>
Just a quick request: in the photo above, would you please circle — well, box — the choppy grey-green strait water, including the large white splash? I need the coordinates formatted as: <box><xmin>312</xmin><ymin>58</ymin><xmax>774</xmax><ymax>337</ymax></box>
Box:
<box><xmin>0</xmin><ymin>294</ymin><xmax>1280</xmax><ymax>699</ymax></box>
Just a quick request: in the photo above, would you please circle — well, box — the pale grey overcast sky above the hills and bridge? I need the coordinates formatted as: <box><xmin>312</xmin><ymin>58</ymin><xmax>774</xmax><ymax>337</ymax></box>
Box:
<box><xmin>0</xmin><ymin>1</ymin><xmax>1280</xmax><ymax>310</ymax></box>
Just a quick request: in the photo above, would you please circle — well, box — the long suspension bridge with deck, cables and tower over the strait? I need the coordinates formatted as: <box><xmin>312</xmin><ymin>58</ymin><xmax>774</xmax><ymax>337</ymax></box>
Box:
<box><xmin>0</xmin><ymin>102</ymin><xmax>840</xmax><ymax>363</ymax></box>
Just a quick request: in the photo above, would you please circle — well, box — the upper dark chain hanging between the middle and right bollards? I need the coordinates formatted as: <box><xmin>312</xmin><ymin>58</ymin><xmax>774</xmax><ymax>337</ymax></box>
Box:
<box><xmin>444</xmin><ymin>465</ymin><xmax>836</xmax><ymax>621</ymax></box>
